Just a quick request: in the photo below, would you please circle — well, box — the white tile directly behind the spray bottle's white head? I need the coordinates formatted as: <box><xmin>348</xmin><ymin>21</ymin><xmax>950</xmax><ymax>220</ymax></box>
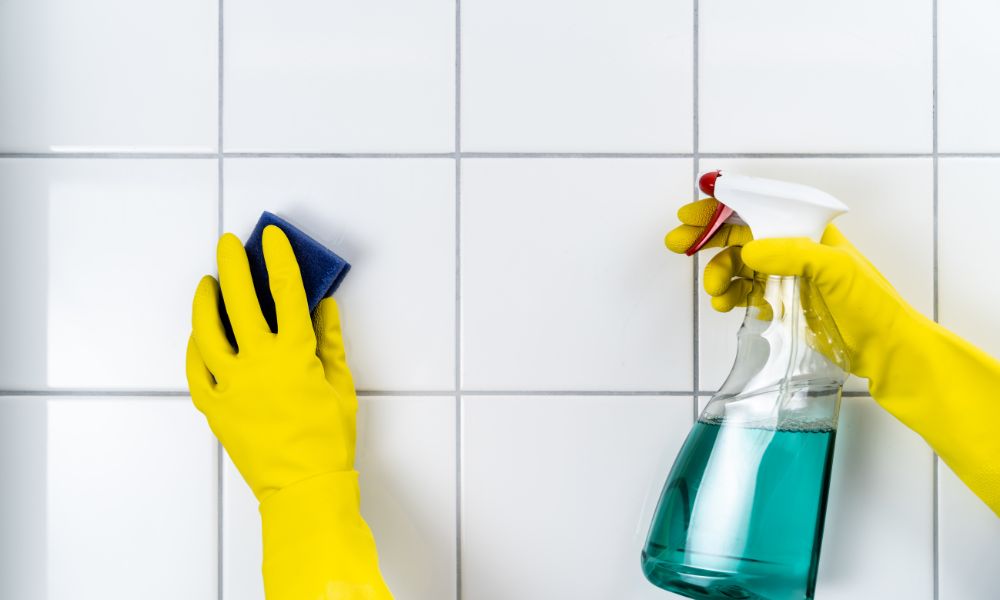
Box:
<box><xmin>698</xmin><ymin>158</ymin><xmax>934</xmax><ymax>391</ymax></box>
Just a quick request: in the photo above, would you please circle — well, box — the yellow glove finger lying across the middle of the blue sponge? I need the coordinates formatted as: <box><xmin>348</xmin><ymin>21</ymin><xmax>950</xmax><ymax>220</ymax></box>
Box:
<box><xmin>263</xmin><ymin>225</ymin><xmax>315</xmax><ymax>345</ymax></box>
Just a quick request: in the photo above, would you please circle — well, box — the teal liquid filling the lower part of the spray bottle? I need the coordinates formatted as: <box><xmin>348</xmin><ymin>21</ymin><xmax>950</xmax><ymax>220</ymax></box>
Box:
<box><xmin>642</xmin><ymin>421</ymin><xmax>836</xmax><ymax>600</ymax></box>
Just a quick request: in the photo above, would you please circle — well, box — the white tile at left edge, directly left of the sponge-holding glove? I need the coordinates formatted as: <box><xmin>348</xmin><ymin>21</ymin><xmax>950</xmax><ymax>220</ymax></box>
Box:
<box><xmin>0</xmin><ymin>159</ymin><xmax>218</xmax><ymax>389</ymax></box>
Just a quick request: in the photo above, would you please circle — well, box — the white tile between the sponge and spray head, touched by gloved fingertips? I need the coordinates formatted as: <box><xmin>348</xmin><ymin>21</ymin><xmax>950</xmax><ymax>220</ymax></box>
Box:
<box><xmin>461</xmin><ymin>159</ymin><xmax>692</xmax><ymax>391</ymax></box>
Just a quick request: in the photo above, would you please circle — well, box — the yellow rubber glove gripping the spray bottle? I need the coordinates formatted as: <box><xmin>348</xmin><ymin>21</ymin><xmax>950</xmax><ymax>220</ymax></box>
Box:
<box><xmin>666</xmin><ymin>198</ymin><xmax>1000</xmax><ymax>515</ymax></box>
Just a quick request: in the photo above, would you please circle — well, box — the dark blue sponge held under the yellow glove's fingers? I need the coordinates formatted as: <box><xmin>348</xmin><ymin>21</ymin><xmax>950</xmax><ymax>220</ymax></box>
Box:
<box><xmin>245</xmin><ymin>211</ymin><xmax>351</xmax><ymax>332</ymax></box>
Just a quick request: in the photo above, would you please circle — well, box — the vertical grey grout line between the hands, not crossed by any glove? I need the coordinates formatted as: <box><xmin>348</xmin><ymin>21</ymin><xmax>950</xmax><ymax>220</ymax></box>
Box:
<box><xmin>454</xmin><ymin>0</ymin><xmax>463</xmax><ymax>600</ymax></box>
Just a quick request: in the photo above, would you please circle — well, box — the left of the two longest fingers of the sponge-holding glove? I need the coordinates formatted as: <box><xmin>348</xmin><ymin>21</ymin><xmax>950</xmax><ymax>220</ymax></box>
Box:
<box><xmin>216</xmin><ymin>233</ymin><xmax>271</xmax><ymax>346</ymax></box>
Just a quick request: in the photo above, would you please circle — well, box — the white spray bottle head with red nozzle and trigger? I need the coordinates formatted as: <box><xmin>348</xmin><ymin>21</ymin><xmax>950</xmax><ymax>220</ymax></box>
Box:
<box><xmin>687</xmin><ymin>171</ymin><xmax>847</xmax><ymax>256</ymax></box>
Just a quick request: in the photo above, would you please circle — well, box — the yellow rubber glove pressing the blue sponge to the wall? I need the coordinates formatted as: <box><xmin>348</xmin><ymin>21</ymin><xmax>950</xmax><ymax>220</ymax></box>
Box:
<box><xmin>187</xmin><ymin>225</ymin><xmax>392</xmax><ymax>600</ymax></box>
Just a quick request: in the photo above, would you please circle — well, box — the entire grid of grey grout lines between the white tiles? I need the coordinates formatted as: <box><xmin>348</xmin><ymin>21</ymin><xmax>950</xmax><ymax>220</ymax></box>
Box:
<box><xmin>0</xmin><ymin>5</ymin><xmax>952</xmax><ymax>600</ymax></box>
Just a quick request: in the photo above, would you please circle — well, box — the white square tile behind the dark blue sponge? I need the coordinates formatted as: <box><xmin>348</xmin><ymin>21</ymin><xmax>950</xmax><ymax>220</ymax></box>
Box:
<box><xmin>224</xmin><ymin>159</ymin><xmax>455</xmax><ymax>390</ymax></box>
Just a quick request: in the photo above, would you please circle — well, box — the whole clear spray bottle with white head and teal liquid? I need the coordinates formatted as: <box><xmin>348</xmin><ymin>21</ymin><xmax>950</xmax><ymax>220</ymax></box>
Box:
<box><xmin>642</xmin><ymin>171</ymin><xmax>849</xmax><ymax>600</ymax></box>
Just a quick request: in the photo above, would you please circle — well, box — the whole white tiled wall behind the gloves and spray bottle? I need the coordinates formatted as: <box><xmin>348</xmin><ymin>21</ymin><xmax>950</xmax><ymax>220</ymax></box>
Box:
<box><xmin>0</xmin><ymin>0</ymin><xmax>1000</xmax><ymax>600</ymax></box>
